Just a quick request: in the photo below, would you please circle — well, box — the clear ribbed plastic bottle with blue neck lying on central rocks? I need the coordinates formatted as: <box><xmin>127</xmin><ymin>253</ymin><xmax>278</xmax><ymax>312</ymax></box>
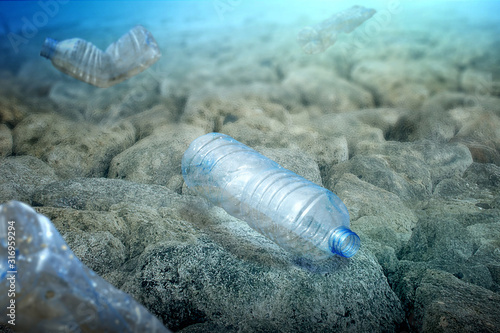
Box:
<box><xmin>182</xmin><ymin>133</ymin><xmax>360</xmax><ymax>260</ymax></box>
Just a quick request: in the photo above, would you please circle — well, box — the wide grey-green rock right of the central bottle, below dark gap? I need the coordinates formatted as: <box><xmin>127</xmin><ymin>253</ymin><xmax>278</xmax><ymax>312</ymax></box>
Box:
<box><xmin>330</xmin><ymin>141</ymin><xmax>472</xmax><ymax>202</ymax></box>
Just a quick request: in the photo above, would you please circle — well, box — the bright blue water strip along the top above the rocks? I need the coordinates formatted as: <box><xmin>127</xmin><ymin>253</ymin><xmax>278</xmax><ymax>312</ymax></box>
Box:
<box><xmin>0</xmin><ymin>0</ymin><xmax>500</xmax><ymax>63</ymax></box>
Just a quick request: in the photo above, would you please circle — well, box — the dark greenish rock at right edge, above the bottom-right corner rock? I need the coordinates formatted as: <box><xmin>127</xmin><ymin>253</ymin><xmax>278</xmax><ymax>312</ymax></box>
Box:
<box><xmin>398</xmin><ymin>185</ymin><xmax>500</xmax><ymax>291</ymax></box>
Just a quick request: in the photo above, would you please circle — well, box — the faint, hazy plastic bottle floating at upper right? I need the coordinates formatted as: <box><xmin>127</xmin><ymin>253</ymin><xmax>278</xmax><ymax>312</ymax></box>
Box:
<box><xmin>297</xmin><ymin>6</ymin><xmax>376</xmax><ymax>54</ymax></box>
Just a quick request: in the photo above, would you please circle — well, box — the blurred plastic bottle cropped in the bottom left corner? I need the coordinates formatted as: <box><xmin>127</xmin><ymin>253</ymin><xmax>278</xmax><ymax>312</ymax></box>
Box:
<box><xmin>0</xmin><ymin>201</ymin><xmax>170</xmax><ymax>333</ymax></box>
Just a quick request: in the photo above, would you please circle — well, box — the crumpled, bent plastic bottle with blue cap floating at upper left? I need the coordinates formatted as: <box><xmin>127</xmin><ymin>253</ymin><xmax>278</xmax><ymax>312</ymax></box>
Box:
<box><xmin>40</xmin><ymin>25</ymin><xmax>161</xmax><ymax>88</ymax></box>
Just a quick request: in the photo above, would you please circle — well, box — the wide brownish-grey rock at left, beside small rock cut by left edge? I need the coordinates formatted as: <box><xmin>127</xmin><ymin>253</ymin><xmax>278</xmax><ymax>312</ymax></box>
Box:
<box><xmin>13</xmin><ymin>114</ymin><xmax>135</xmax><ymax>178</ymax></box>
